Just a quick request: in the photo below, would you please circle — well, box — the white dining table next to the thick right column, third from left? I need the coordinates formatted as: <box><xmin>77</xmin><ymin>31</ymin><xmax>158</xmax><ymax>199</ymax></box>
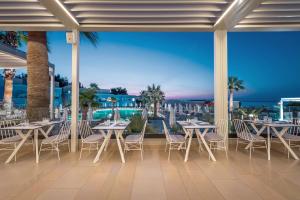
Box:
<box><xmin>177</xmin><ymin>121</ymin><xmax>216</xmax><ymax>162</ymax></box>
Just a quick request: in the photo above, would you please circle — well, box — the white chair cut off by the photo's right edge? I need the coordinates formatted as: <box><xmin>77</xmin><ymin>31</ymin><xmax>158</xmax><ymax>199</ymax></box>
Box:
<box><xmin>282</xmin><ymin>119</ymin><xmax>300</xmax><ymax>158</ymax></box>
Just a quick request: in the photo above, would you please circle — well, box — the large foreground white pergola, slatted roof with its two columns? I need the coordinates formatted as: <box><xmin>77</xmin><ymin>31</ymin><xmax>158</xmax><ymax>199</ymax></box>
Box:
<box><xmin>0</xmin><ymin>0</ymin><xmax>300</xmax><ymax>152</ymax></box>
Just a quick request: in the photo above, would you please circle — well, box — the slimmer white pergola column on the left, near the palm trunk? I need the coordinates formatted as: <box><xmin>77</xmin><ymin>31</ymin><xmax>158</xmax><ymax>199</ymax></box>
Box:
<box><xmin>71</xmin><ymin>30</ymin><xmax>79</xmax><ymax>152</ymax></box>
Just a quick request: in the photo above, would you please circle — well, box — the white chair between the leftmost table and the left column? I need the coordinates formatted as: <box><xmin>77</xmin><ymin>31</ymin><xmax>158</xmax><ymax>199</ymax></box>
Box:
<box><xmin>39</xmin><ymin>121</ymin><xmax>71</xmax><ymax>160</ymax></box>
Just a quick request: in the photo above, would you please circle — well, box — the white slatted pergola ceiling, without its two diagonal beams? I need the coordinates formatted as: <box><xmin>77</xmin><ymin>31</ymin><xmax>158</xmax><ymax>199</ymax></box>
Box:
<box><xmin>0</xmin><ymin>0</ymin><xmax>300</xmax><ymax>31</ymax></box>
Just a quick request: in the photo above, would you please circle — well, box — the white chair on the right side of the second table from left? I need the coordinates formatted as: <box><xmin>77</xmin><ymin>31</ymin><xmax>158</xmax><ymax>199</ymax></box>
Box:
<box><xmin>124</xmin><ymin>120</ymin><xmax>148</xmax><ymax>160</ymax></box>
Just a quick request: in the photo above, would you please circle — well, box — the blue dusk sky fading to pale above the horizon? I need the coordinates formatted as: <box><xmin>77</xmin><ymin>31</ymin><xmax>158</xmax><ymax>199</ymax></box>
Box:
<box><xmin>21</xmin><ymin>32</ymin><xmax>300</xmax><ymax>100</ymax></box>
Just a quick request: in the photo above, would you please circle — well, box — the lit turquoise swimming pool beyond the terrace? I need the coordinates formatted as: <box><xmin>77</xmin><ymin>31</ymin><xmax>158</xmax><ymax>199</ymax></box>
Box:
<box><xmin>93</xmin><ymin>108</ymin><xmax>142</xmax><ymax>120</ymax></box>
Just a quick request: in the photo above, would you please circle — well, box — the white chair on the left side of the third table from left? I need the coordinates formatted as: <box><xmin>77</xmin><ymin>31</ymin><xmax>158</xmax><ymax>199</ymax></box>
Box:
<box><xmin>162</xmin><ymin>121</ymin><xmax>186</xmax><ymax>160</ymax></box>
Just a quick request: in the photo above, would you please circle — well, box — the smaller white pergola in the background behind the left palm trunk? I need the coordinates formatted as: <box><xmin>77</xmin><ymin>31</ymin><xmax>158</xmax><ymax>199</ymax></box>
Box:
<box><xmin>0</xmin><ymin>44</ymin><xmax>55</xmax><ymax>118</ymax></box>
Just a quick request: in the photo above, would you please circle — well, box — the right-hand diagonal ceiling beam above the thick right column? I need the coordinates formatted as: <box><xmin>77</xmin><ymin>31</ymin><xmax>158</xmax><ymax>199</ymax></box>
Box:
<box><xmin>214</xmin><ymin>0</ymin><xmax>263</xmax><ymax>31</ymax></box>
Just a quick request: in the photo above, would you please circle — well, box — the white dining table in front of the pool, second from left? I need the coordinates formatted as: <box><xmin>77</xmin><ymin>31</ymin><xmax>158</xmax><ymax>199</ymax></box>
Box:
<box><xmin>92</xmin><ymin>122</ymin><xmax>130</xmax><ymax>163</ymax></box>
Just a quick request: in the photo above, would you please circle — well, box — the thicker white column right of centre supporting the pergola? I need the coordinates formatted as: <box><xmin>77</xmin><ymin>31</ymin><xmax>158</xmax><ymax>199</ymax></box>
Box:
<box><xmin>214</xmin><ymin>30</ymin><xmax>228</xmax><ymax>138</ymax></box>
